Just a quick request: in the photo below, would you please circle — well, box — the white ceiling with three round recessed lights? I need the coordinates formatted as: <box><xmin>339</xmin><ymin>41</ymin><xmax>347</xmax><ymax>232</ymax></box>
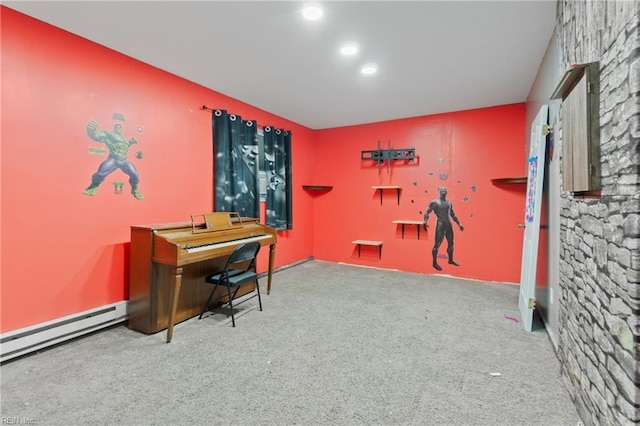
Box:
<box><xmin>3</xmin><ymin>0</ymin><xmax>556</xmax><ymax>129</ymax></box>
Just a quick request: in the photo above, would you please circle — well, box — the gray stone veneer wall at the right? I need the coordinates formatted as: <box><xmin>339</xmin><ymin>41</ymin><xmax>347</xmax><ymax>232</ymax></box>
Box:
<box><xmin>556</xmin><ymin>0</ymin><xmax>640</xmax><ymax>425</ymax></box>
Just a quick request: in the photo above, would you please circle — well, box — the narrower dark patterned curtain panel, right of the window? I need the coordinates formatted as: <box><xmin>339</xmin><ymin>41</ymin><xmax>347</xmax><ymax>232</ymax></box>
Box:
<box><xmin>263</xmin><ymin>126</ymin><xmax>293</xmax><ymax>231</ymax></box>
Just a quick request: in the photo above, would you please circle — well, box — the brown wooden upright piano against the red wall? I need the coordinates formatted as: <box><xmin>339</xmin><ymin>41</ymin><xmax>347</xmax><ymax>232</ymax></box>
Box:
<box><xmin>128</xmin><ymin>212</ymin><xmax>277</xmax><ymax>343</ymax></box>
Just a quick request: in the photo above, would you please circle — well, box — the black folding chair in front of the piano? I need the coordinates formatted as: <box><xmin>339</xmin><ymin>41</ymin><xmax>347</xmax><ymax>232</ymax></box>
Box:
<box><xmin>198</xmin><ymin>241</ymin><xmax>262</xmax><ymax>327</ymax></box>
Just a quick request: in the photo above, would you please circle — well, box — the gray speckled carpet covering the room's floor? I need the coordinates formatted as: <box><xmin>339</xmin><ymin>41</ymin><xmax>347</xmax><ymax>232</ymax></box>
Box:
<box><xmin>0</xmin><ymin>261</ymin><xmax>580</xmax><ymax>425</ymax></box>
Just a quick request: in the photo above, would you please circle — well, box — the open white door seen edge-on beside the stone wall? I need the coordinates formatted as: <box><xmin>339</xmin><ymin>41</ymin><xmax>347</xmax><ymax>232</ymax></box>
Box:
<box><xmin>518</xmin><ymin>105</ymin><xmax>549</xmax><ymax>331</ymax></box>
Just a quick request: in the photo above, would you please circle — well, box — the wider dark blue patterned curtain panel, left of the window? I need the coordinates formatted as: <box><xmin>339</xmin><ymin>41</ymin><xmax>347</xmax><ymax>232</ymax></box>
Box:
<box><xmin>212</xmin><ymin>110</ymin><xmax>260</xmax><ymax>218</ymax></box>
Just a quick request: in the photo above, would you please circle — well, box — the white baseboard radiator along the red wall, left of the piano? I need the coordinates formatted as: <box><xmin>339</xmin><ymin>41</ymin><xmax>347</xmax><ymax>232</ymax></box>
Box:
<box><xmin>0</xmin><ymin>300</ymin><xmax>127</xmax><ymax>363</ymax></box>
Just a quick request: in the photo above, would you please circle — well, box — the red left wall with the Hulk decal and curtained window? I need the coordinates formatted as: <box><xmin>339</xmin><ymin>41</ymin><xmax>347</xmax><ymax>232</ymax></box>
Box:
<box><xmin>0</xmin><ymin>7</ymin><xmax>313</xmax><ymax>332</ymax></box>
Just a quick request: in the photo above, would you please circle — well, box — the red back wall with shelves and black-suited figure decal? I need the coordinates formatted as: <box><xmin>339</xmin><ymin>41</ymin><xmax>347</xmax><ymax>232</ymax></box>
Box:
<box><xmin>310</xmin><ymin>104</ymin><xmax>525</xmax><ymax>282</ymax></box>
